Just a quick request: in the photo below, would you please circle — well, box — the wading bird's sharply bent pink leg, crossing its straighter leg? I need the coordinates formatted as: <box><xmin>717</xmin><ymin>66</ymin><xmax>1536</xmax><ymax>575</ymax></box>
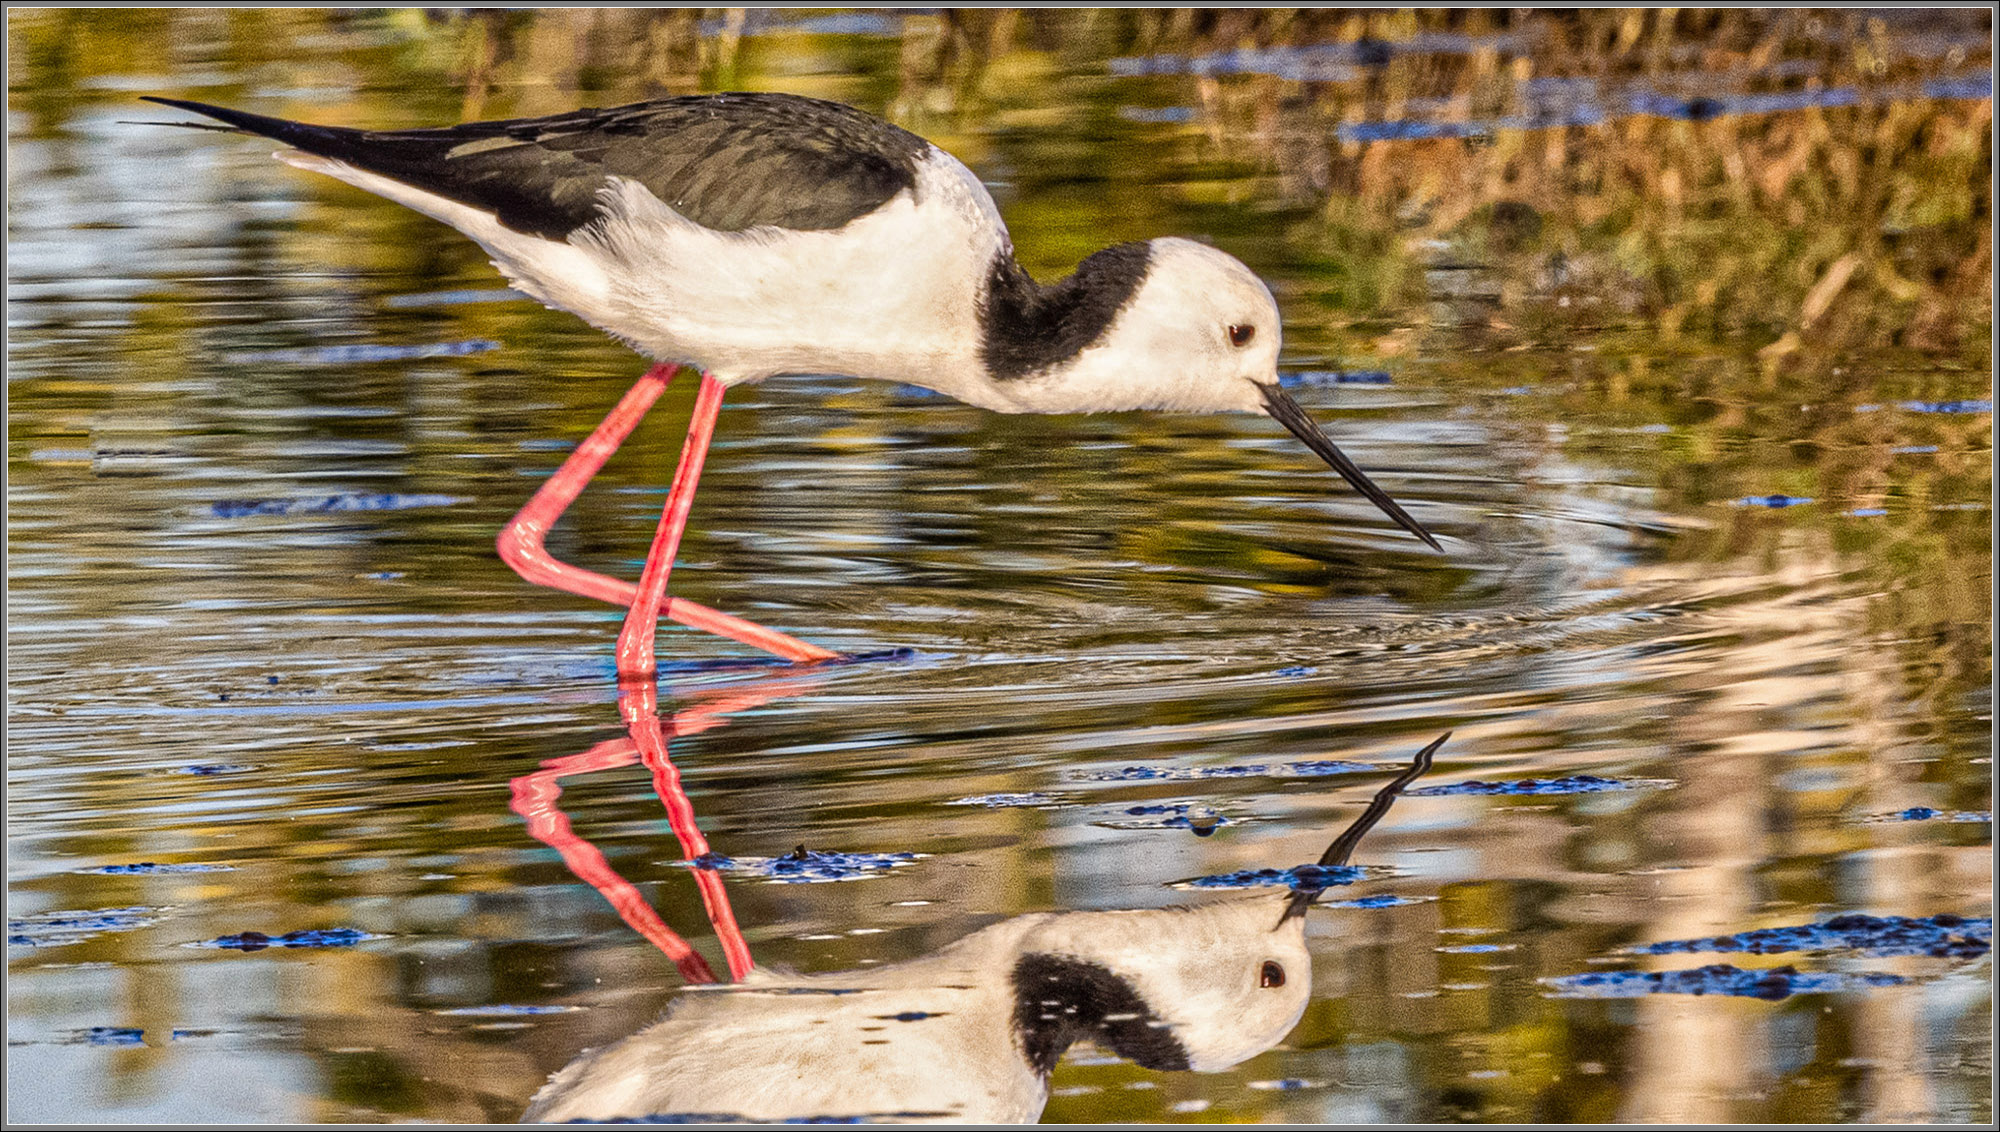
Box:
<box><xmin>500</xmin><ymin>364</ymin><xmax>840</xmax><ymax>672</ymax></box>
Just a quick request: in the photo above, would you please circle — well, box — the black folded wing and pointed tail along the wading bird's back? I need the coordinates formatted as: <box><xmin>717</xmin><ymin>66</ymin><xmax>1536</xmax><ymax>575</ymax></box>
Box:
<box><xmin>146</xmin><ymin>94</ymin><xmax>930</xmax><ymax>240</ymax></box>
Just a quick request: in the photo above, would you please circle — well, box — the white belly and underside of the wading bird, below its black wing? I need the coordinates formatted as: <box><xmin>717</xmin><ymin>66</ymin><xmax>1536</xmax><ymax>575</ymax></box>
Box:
<box><xmin>280</xmin><ymin>148</ymin><xmax>1016</xmax><ymax>410</ymax></box>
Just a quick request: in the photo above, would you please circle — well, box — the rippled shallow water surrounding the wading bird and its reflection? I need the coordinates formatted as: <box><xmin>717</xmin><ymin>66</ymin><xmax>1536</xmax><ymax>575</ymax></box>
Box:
<box><xmin>8</xmin><ymin>10</ymin><xmax>1992</xmax><ymax>1122</ymax></box>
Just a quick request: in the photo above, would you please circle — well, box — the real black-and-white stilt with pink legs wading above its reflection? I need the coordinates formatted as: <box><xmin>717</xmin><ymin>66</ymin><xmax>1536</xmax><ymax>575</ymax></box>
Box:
<box><xmin>150</xmin><ymin>94</ymin><xmax>1440</xmax><ymax>676</ymax></box>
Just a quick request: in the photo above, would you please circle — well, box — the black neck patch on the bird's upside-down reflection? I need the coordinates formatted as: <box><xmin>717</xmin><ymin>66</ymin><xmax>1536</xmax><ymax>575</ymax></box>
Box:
<box><xmin>1014</xmin><ymin>954</ymin><xmax>1188</xmax><ymax>1076</ymax></box>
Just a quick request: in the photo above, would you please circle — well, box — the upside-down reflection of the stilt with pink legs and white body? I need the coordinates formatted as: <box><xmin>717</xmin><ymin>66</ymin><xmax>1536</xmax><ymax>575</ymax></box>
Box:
<box><xmin>514</xmin><ymin>686</ymin><xmax>1448</xmax><ymax>1124</ymax></box>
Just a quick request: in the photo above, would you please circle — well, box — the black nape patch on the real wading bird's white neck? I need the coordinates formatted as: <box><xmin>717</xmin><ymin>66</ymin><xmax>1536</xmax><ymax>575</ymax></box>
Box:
<box><xmin>980</xmin><ymin>244</ymin><xmax>1152</xmax><ymax>380</ymax></box>
